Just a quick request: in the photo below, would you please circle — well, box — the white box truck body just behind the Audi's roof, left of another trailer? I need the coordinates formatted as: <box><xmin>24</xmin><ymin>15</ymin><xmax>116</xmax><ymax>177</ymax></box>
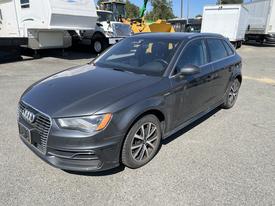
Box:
<box><xmin>201</xmin><ymin>4</ymin><xmax>248</xmax><ymax>47</ymax></box>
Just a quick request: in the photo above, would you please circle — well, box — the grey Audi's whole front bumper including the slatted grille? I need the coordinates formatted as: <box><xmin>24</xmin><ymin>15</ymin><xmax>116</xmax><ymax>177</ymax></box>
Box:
<box><xmin>17</xmin><ymin>100</ymin><xmax>124</xmax><ymax>171</ymax></box>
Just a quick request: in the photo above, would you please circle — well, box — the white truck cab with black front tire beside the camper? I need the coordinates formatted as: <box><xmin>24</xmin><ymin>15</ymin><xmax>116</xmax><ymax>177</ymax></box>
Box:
<box><xmin>80</xmin><ymin>10</ymin><xmax>132</xmax><ymax>53</ymax></box>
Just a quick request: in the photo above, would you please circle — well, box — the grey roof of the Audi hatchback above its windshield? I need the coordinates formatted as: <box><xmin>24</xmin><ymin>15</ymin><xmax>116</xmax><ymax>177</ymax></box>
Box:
<box><xmin>134</xmin><ymin>32</ymin><xmax>224</xmax><ymax>40</ymax></box>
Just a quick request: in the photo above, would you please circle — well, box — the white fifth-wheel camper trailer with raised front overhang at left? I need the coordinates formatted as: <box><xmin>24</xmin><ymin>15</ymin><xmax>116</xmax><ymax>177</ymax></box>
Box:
<box><xmin>0</xmin><ymin>0</ymin><xmax>98</xmax><ymax>50</ymax></box>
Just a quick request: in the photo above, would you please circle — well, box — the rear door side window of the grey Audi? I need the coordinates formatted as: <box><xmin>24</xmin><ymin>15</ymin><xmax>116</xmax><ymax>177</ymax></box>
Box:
<box><xmin>207</xmin><ymin>38</ymin><xmax>228</xmax><ymax>61</ymax></box>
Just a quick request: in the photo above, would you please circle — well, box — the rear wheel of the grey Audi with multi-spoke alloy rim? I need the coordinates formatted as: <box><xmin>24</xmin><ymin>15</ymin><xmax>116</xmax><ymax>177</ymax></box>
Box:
<box><xmin>222</xmin><ymin>78</ymin><xmax>241</xmax><ymax>109</ymax></box>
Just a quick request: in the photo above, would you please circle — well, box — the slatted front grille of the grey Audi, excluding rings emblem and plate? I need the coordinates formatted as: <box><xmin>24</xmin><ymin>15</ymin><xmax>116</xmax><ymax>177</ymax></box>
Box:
<box><xmin>18</xmin><ymin>102</ymin><xmax>51</xmax><ymax>154</ymax></box>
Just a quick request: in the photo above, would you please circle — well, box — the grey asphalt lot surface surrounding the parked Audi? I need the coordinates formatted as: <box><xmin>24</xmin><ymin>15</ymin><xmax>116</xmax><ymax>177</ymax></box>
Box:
<box><xmin>0</xmin><ymin>46</ymin><xmax>275</xmax><ymax>206</ymax></box>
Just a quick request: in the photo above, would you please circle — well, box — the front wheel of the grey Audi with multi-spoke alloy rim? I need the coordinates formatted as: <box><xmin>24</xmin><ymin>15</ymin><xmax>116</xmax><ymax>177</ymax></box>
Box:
<box><xmin>121</xmin><ymin>115</ymin><xmax>162</xmax><ymax>169</ymax></box>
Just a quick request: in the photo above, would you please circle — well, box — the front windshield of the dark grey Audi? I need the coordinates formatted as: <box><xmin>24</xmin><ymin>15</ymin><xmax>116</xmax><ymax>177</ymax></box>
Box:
<box><xmin>95</xmin><ymin>36</ymin><xmax>183</xmax><ymax>76</ymax></box>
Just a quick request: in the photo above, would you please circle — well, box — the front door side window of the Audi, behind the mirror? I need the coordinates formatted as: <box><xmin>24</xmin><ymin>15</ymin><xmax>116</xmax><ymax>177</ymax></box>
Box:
<box><xmin>175</xmin><ymin>40</ymin><xmax>207</xmax><ymax>73</ymax></box>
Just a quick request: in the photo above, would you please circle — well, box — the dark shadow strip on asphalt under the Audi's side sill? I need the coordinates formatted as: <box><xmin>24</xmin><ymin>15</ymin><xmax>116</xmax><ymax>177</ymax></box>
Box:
<box><xmin>162</xmin><ymin>107</ymin><xmax>221</xmax><ymax>145</ymax></box>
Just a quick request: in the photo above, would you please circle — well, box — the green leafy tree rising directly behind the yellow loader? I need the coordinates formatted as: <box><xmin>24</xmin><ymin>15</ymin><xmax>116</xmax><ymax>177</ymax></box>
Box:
<box><xmin>145</xmin><ymin>0</ymin><xmax>175</xmax><ymax>21</ymax></box>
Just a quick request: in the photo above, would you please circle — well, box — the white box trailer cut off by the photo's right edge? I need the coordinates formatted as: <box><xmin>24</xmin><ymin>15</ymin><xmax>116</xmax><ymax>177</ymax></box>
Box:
<box><xmin>244</xmin><ymin>0</ymin><xmax>275</xmax><ymax>43</ymax></box>
